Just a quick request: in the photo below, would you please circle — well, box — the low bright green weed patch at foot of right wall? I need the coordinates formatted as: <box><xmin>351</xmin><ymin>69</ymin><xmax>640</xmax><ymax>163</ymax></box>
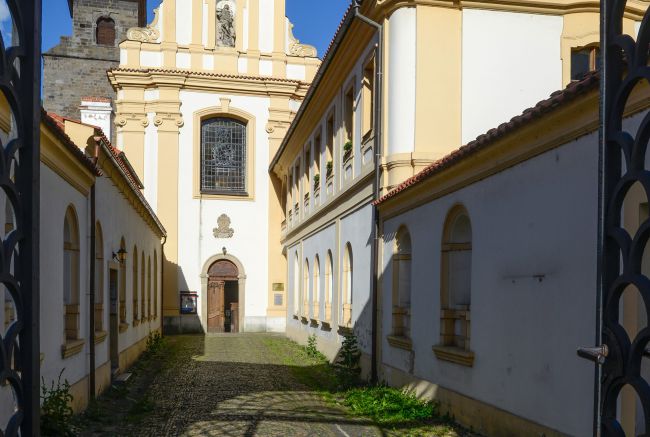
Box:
<box><xmin>343</xmin><ymin>386</ymin><xmax>439</xmax><ymax>425</ymax></box>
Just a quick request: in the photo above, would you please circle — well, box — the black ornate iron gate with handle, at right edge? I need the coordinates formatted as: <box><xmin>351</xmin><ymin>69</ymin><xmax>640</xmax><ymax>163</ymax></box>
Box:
<box><xmin>579</xmin><ymin>0</ymin><xmax>650</xmax><ymax>437</ymax></box>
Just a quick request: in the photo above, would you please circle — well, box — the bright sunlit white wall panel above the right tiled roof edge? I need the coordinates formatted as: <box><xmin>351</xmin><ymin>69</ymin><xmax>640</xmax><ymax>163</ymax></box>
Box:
<box><xmin>462</xmin><ymin>9</ymin><xmax>563</xmax><ymax>144</ymax></box>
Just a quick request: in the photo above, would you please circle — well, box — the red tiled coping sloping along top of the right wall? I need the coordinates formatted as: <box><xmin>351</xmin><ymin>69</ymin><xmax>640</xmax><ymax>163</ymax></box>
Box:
<box><xmin>374</xmin><ymin>72</ymin><xmax>600</xmax><ymax>205</ymax></box>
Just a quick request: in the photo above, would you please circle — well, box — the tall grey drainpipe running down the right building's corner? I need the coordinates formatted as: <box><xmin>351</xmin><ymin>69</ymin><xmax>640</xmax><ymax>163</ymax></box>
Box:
<box><xmin>353</xmin><ymin>0</ymin><xmax>384</xmax><ymax>383</ymax></box>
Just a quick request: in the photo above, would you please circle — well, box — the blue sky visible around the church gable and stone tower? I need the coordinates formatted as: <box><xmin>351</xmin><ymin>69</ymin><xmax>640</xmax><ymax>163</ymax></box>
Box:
<box><xmin>41</xmin><ymin>0</ymin><xmax>350</xmax><ymax>56</ymax></box>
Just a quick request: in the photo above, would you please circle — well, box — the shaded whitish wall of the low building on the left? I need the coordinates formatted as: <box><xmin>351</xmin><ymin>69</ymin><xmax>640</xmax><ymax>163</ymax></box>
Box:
<box><xmin>40</xmin><ymin>164</ymin><xmax>162</xmax><ymax>396</ymax></box>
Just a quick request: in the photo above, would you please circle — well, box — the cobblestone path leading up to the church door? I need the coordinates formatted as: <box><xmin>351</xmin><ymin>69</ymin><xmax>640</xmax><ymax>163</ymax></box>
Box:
<box><xmin>95</xmin><ymin>334</ymin><xmax>382</xmax><ymax>437</ymax></box>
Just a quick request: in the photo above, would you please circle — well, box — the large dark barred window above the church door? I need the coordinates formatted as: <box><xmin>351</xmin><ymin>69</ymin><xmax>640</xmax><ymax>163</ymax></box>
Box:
<box><xmin>201</xmin><ymin>117</ymin><xmax>247</xmax><ymax>195</ymax></box>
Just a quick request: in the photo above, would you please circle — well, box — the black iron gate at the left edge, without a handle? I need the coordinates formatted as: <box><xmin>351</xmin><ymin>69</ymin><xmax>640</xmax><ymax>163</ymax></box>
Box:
<box><xmin>0</xmin><ymin>0</ymin><xmax>41</xmax><ymax>436</ymax></box>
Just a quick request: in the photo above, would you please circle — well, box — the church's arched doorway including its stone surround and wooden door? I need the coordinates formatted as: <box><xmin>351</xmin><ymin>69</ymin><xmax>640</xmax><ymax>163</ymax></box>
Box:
<box><xmin>201</xmin><ymin>255</ymin><xmax>246</xmax><ymax>333</ymax></box>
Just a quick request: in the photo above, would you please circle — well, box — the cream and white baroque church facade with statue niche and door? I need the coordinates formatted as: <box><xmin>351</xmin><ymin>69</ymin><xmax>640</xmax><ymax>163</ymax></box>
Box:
<box><xmin>108</xmin><ymin>0</ymin><xmax>320</xmax><ymax>333</ymax></box>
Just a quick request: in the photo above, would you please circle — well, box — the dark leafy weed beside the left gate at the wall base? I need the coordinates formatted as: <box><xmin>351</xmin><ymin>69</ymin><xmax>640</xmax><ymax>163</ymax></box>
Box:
<box><xmin>41</xmin><ymin>368</ymin><xmax>76</xmax><ymax>437</ymax></box>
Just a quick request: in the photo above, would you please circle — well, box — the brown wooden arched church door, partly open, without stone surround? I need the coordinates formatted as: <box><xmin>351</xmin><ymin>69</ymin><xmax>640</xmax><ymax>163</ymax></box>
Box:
<box><xmin>207</xmin><ymin>260</ymin><xmax>239</xmax><ymax>333</ymax></box>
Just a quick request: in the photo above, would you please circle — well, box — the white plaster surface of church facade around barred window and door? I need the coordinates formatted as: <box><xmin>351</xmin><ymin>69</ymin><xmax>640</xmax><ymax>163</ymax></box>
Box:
<box><xmin>178</xmin><ymin>91</ymin><xmax>270</xmax><ymax>330</ymax></box>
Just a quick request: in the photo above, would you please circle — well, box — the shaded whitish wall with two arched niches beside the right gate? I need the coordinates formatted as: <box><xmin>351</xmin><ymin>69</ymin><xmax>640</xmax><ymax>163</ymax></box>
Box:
<box><xmin>381</xmin><ymin>129</ymin><xmax>598</xmax><ymax>436</ymax></box>
